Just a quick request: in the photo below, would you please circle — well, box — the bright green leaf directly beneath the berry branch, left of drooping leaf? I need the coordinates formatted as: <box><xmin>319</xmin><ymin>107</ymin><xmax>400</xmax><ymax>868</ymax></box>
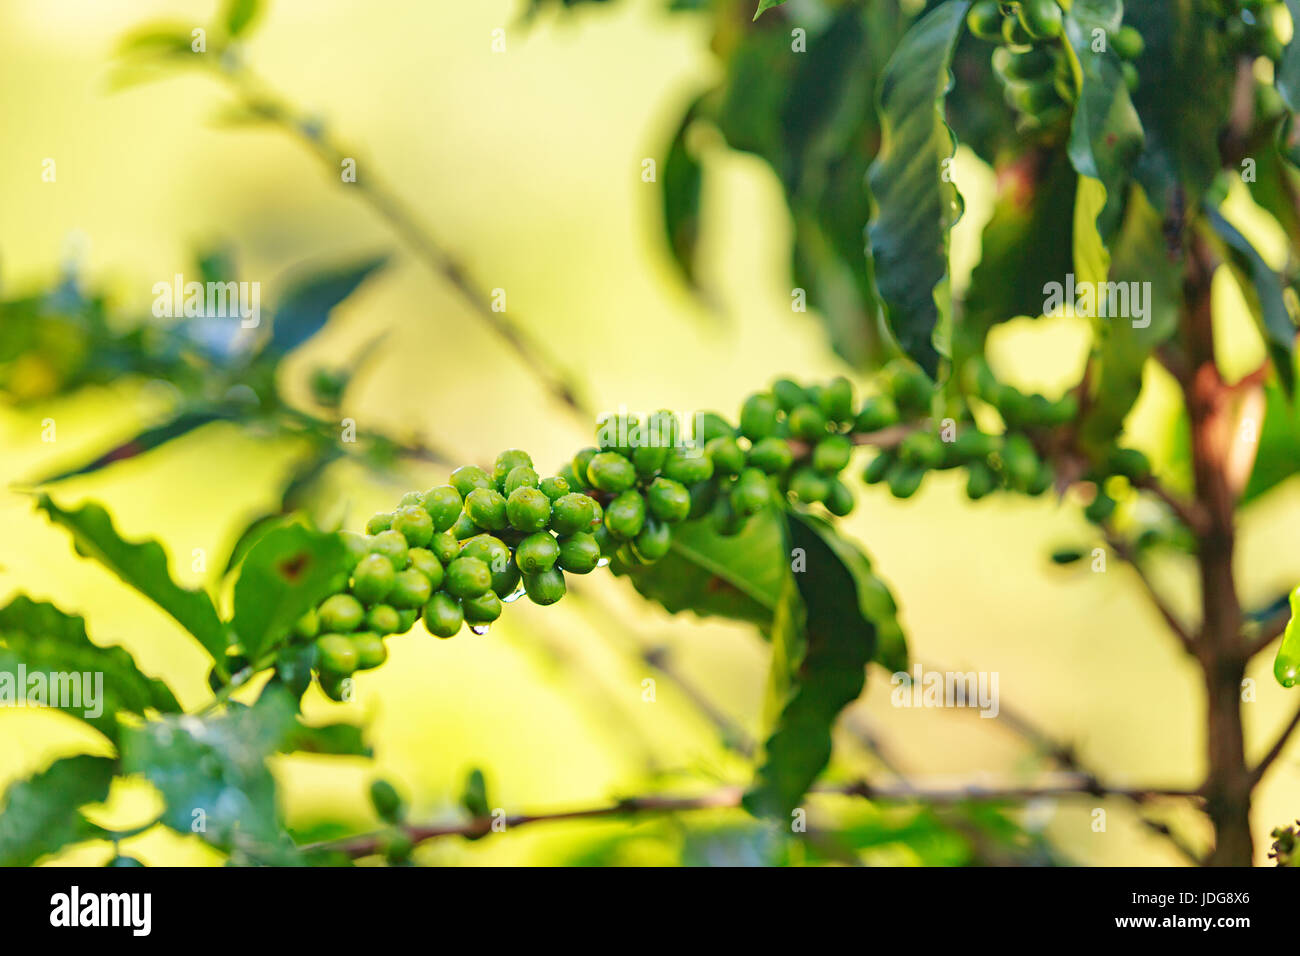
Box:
<box><xmin>611</xmin><ymin>509</ymin><xmax>789</xmax><ymax>628</ymax></box>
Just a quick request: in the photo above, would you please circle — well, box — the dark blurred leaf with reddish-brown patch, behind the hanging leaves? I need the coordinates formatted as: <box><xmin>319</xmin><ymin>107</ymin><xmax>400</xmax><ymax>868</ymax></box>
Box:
<box><xmin>954</xmin><ymin>147</ymin><xmax>1078</xmax><ymax>359</ymax></box>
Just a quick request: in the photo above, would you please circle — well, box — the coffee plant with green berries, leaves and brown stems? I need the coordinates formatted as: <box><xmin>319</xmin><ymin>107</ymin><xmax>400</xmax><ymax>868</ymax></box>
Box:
<box><xmin>0</xmin><ymin>0</ymin><xmax>1300</xmax><ymax>865</ymax></box>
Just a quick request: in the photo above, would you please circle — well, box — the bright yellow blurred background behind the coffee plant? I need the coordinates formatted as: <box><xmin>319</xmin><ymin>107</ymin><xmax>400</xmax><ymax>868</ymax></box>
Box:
<box><xmin>0</xmin><ymin>0</ymin><xmax>1300</xmax><ymax>865</ymax></box>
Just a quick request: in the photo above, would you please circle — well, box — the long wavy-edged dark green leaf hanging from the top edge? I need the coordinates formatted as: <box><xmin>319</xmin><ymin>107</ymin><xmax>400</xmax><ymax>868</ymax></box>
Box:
<box><xmin>868</xmin><ymin>0</ymin><xmax>970</xmax><ymax>377</ymax></box>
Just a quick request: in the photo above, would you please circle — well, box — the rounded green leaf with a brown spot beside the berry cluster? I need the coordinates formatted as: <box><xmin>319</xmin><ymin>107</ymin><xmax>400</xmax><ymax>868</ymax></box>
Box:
<box><xmin>230</xmin><ymin>524</ymin><xmax>347</xmax><ymax>662</ymax></box>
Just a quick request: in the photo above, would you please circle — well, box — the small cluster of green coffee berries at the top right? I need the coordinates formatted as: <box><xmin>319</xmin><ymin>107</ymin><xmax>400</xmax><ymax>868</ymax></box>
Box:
<box><xmin>966</xmin><ymin>0</ymin><xmax>1144</xmax><ymax>127</ymax></box>
